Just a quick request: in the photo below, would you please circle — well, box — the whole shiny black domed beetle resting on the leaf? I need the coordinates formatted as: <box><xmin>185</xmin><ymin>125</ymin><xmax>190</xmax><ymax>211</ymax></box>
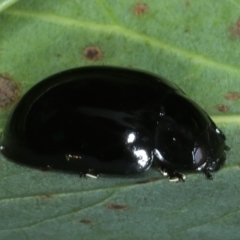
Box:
<box><xmin>1</xmin><ymin>67</ymin><xmax>229</xmax><ymax>181</ymax></box>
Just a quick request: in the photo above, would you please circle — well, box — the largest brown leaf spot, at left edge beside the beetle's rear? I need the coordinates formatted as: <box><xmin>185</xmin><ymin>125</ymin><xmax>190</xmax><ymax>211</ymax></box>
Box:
<box><xmin>0</xmin><ymin>74</ymin><xmax>20</xmax><ymax>109</ymax></box>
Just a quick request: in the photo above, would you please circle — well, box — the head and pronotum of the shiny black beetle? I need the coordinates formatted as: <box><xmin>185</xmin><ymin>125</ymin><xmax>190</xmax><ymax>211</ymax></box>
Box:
<box><xmin>154</xmin><ymin>95</ymin><xmax>228</xmax><ymax>171</ymax></box>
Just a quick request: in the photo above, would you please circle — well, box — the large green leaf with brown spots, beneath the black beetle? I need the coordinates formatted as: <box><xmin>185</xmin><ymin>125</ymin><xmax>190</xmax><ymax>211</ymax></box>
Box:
<box><xmin>0</xmin><ymin>0</ymin><xmax>240</xmax><ymax>239</ymax></box>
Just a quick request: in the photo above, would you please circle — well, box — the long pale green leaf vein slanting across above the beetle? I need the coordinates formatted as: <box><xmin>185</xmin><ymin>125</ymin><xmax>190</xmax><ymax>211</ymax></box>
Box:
<box><xmin>4</xmin><ymin>8</ymin><xmax>240</xmax><ymax>74</ymax></box>
